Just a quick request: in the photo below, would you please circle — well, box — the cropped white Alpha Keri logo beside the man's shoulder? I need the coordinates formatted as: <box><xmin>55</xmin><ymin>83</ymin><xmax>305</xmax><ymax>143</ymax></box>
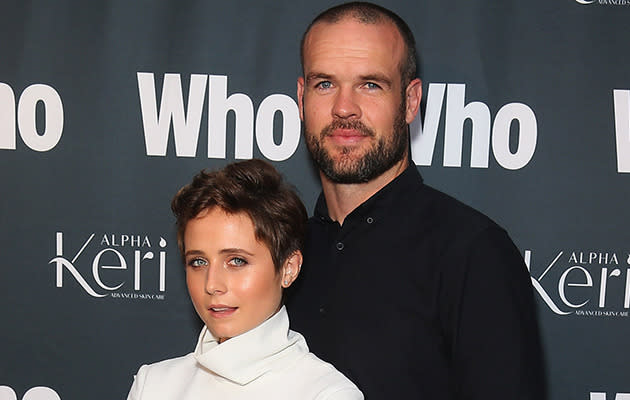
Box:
<box><xmin>525</xmin><ymin>250</ymin><xmax>630</xmax><ymax>317</ymax></box>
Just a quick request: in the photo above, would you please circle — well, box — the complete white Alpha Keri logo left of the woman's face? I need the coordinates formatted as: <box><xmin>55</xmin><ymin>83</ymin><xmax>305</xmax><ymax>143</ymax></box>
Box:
<box><xmin>48</xmin><ymin>232</ymin><xmax>167</xmax><ymax>300</ymax></box>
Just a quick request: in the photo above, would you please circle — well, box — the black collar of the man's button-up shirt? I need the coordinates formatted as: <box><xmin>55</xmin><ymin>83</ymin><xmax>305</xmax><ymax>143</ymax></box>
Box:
<box><xmin>313</xmin><ymin>160</ymin><xmax>422</xmax><ymax>225</ymax></box>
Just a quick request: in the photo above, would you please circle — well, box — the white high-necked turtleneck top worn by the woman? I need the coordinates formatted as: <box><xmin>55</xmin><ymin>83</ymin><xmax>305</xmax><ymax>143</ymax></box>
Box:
<box><xmin>127</xmin><ymin>307</ymin><xmax>363</xmax><ymax>400</ymax></box>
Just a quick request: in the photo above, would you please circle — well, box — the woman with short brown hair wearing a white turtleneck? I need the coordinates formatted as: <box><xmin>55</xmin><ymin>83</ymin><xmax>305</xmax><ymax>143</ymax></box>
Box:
<box><xmin>128</xmin><ymin>160</ymin><xmax>363</xmax><ymax>400</ymax></box>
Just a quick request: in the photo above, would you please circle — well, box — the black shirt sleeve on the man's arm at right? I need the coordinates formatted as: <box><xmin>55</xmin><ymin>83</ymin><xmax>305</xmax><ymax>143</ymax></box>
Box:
<box><xmin>448</xmin><ymin>226</ymin><xmax>547</xmax><ymax>400</ymax></box>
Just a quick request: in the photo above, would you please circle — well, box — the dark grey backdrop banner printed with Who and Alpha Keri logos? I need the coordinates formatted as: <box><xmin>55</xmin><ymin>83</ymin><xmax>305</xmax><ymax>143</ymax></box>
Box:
<box><xmin>0</xmin><ymin>0</ymin><xmax>630</xmax><ymax>400</ymax></box>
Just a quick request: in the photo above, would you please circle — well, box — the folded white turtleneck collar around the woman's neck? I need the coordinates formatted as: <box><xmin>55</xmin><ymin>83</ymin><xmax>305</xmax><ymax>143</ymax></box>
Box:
<box><xmin>194</xmin><ymin>306</ymin><xmax>308</xmax><ymax>385</ymax></box>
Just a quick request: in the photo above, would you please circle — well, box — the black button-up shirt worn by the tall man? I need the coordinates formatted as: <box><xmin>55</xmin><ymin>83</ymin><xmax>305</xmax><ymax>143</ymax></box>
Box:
<box><xmin>288</xmin><ymin>164</ymin><xmax>546</xmax><ymax>400</ymax></box>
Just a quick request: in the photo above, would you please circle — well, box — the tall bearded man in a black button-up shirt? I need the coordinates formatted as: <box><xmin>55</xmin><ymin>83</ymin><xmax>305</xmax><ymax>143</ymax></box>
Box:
<box><xmin>289</xmin><ymin>3</ymin><xmax>546</xmax><ymax>400</ymax></box>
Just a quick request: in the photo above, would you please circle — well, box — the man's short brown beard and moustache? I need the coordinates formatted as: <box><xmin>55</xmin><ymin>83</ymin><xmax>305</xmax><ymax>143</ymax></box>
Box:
<box><xmin>302</xmin><ymin>101</ymin><xmax>409</xmax><ymax>184</ymax></box>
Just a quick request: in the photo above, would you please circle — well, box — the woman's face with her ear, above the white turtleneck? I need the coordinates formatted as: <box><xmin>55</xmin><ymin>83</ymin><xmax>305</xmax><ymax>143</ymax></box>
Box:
<box><xmin>184</xmin><ymin>207</ymin><xmax>301</xmax><ymax>342</ymax></box>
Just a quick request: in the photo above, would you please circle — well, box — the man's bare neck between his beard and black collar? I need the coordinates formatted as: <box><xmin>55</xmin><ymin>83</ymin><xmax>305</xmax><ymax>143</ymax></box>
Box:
<box><xmin>319</xmin><ymin>157</ymin><xmax>409</xmax><ymax>225</ymax></box>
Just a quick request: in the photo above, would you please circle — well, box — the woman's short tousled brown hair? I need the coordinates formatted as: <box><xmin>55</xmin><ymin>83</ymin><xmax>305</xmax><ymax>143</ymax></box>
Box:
<box><xmin>171</xmin><ymin>159</ymin><xmax>307</xmax><ymax>271</ymax></box>
